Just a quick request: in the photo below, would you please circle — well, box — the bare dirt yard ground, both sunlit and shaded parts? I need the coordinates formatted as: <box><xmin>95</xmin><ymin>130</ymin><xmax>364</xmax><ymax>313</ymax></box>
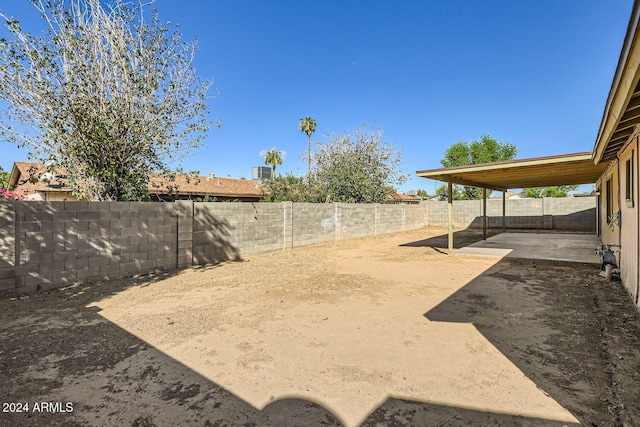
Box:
<box><xmin>0</xmin><ymin>229</ymin><xmax>640</xmax><ymax>427</ymax></box>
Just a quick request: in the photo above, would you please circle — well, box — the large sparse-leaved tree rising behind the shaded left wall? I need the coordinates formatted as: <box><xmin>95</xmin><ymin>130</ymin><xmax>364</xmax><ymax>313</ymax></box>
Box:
<box><xmin>0</xmin><ymin>0</ymin><xmax>210</xmax><ymax>200</ymax></box>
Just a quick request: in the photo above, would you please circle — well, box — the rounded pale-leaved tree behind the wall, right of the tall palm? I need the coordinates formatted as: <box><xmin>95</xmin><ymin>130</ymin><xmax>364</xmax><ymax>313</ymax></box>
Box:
<box><xmin>314</xmin><ymin>125</ymin><xmax>408</xmax><ymax>203</ymax></box>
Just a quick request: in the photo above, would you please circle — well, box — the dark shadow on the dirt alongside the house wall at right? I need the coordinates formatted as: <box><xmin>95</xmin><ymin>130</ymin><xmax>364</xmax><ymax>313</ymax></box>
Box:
<box><xmin>425</xmin><ymin>260</ymin><xmax>640</xmax><ymax>426</ymax></box>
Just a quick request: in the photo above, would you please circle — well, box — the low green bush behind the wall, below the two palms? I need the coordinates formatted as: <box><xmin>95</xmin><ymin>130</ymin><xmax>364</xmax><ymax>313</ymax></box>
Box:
<box><xmin>262</xmin><ymin>175</ymin><xmax>327</xmax><ymax>203</ymax></box>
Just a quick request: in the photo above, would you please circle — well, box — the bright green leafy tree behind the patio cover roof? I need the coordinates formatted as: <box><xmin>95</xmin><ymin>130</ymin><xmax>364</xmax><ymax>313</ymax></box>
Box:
<box><xmin>436</xmin><ymin>135</ymin><xmax>518</xmax><ymax>200</ymax></box>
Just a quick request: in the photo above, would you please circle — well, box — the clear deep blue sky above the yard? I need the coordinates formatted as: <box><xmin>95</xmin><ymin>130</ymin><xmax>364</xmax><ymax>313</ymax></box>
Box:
<box><xmin>0</xmin><ymin>0</ymin><xmax>633</xmax><ymax>193</ymax></box>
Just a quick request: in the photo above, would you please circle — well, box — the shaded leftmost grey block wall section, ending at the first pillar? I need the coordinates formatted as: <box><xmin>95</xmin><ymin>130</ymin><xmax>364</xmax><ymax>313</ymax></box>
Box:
<box><xmin>0</xmin><ymin>201</ymin><xmax>177</xmax><ymax>291</ymax></box>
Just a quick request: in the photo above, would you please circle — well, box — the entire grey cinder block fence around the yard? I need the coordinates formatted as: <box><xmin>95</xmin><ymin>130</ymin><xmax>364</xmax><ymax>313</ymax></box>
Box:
<box><xmin>0</xmin><ymin>198</ymin><xmax>595</xmax><ymax>292</ymax></box>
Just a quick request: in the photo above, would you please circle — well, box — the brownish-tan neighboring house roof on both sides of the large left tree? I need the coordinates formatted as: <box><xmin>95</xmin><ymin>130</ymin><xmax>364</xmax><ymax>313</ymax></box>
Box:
<box><xmin>9</xmin><ymin>162</ymin><xmax>262</xmax><ymax>200</ymax></box>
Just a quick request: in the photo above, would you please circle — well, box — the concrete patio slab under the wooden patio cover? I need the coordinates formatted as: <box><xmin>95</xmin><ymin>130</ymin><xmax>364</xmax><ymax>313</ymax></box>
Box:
<box><xmin>456</xmin><ymin>233</ymin><xmax>600</xmax><ymax>265</ymax></box>
